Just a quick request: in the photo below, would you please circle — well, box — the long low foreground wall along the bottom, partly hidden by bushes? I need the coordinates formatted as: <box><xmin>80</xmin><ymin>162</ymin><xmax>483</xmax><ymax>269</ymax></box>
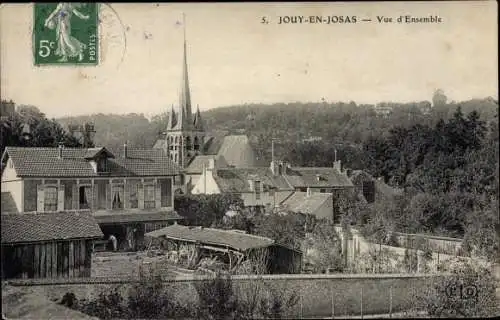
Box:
<box><xmin>17</xmin><ymin>274</ymin><xmax>444</xmax><ymax>318</ymax></box>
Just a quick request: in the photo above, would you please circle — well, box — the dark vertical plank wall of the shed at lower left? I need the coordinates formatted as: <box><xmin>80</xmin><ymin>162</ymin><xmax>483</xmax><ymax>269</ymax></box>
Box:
<box><xmin>2</xmin><ymin>240</ymin><xmax>92</xmax><ymax>278</ymax></box>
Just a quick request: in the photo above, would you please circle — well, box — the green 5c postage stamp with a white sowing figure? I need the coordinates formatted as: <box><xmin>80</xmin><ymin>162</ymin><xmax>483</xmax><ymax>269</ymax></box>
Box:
<box><xmin>33</xmin><ymin>2</ymin><xmax>99</xmax><ymax>65</ymax></box>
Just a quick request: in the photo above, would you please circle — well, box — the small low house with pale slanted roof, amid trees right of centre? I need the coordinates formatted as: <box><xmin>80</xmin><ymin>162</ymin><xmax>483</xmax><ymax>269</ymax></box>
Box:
<box><xmin>280</xmin><ymin>191</ymin><xmax>334</xmax><ymax>220</ymax></box>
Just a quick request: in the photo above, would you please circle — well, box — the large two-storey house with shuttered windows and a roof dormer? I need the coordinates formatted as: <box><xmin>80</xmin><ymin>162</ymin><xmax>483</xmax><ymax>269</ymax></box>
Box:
<box><xmin>2</xmin><ymin>145</ymin><xmax>181</xmax><ymax>252</ymax></box>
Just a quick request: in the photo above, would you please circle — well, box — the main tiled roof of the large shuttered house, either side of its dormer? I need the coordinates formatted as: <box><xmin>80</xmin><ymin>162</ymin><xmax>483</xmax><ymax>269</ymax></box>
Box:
<box><xmin>5</xmin><ymin>147</ymin><xmax>180</xmax><ymax>177</ymax></box>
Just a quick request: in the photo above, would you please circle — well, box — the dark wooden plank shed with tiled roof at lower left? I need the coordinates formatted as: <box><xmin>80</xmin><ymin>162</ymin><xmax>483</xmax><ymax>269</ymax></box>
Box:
<box><xmin>1</xmin><ymin>212</ymin><xmax>103</xmax><ymax>279</ymax></box>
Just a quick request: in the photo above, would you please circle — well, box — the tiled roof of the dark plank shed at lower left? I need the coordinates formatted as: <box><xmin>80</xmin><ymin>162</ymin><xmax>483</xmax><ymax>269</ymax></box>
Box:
<box><xmin>2</xmin><ymin>212</ymin><xmax>104</xmax><ymax>244</ymax></box>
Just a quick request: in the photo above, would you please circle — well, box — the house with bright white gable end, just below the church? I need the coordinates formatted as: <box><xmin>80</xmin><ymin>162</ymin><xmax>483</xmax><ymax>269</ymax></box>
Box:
<box><xmin>191</xmin><ymin>159</ymin><xmax>293</xmax><ymax>209</ymax></box>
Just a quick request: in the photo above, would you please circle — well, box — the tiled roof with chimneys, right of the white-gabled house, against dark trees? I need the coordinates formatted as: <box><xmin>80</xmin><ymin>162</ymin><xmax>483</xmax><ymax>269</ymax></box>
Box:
<box><xmin>285</xmin><ymin>167</ymin><xmax>354</xmax><ymax>188</ymax></box>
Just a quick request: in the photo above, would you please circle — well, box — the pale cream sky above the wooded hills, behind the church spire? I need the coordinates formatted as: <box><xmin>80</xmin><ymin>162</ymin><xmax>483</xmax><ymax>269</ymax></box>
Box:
<box><xmin>0</xmin><ymin>1</ymin><xmax>498</xmax><ymax>117</ymax></box>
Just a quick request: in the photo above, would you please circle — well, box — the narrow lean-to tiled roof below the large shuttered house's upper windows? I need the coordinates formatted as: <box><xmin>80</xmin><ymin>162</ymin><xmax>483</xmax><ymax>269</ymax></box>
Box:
<box><xmin>93</xmin><ymin>209</ymin><xmax>183</xmax><ymax>224</ymax></box>
